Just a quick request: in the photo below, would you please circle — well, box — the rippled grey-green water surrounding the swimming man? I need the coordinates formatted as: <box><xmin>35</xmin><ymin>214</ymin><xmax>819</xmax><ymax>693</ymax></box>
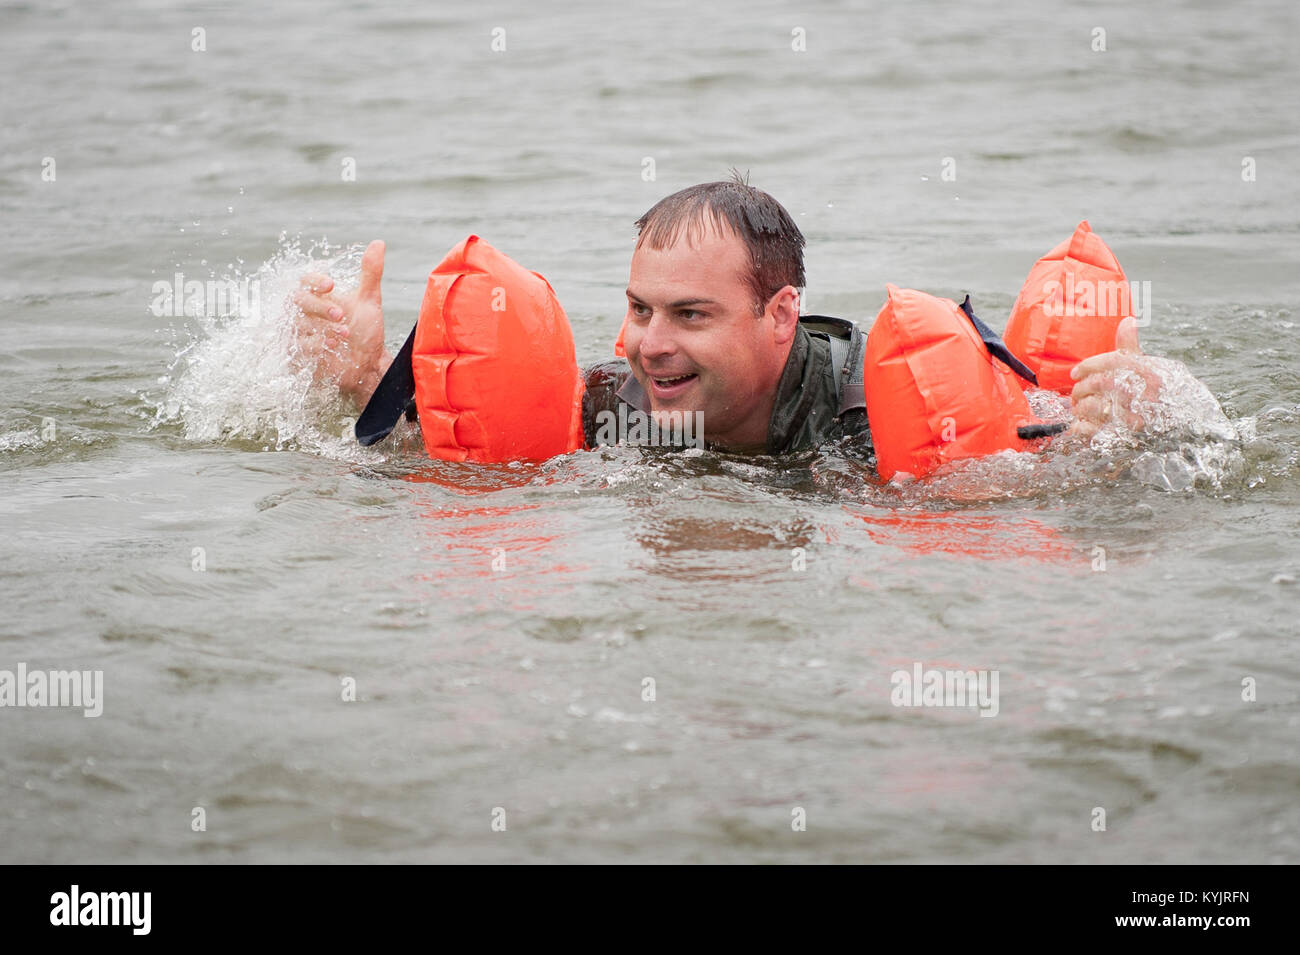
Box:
<box><xmin>0</xmin><ymin>1</ymin><xmax>1300</xmax><ymax>863</ymax></box>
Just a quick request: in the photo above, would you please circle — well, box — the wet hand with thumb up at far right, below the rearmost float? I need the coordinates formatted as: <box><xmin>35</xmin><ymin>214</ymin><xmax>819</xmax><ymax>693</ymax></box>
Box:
<box><xmin>1070</xmin><ymin>317</ymin><xmax>1162</xmax><ymax>438</ymax></box>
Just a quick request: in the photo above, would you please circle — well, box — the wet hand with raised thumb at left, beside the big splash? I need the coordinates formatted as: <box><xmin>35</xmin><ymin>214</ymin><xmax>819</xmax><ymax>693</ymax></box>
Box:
<box><xmin>293</xmin><ymin>239</ymin><xmax>393</xmax><ymax>405</ymax></box>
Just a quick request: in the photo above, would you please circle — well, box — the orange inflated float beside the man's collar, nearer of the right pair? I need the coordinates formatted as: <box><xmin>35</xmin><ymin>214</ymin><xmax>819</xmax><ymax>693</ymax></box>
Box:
<box><xmin>866</xmin><ymin>285</ymin><xmax>1041</xmax><ymax>481</ymax></box>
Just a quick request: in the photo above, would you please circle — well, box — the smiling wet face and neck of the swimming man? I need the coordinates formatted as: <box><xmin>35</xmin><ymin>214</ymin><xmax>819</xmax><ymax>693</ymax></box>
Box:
<box><xmin>623</xmin><ymin>226</ymin><xmax>798</xmax><ymax>450</ymax></box>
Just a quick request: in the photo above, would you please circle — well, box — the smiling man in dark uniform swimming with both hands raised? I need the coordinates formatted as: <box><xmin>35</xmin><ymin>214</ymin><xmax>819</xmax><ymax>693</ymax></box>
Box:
<box><xmin>294</xmin><ymin>177</ymin><xmax>1190</xmax><ymax>453</ymax></box>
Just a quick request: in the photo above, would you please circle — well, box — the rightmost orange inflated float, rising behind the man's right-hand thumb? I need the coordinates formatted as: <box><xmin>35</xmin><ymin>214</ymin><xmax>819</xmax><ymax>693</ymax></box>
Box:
<box><xmin>1002</xmin><ymin>220</ymin><xmax>1132</xmax><ymax>395</ymax></box>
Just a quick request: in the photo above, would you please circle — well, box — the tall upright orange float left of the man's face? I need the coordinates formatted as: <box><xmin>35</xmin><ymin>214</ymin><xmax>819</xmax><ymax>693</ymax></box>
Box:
<box><xmin>411</xmin><ymin>235</ymin><xmax>584</xmax><ymax>463</ymax></box>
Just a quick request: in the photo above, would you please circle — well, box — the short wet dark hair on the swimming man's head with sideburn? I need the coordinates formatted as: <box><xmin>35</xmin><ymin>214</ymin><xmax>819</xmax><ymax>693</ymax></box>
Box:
<box><xmin>636</xmin><ymin>169</ymin><xmax>805</xmax><ymax>314</ymax></box>
